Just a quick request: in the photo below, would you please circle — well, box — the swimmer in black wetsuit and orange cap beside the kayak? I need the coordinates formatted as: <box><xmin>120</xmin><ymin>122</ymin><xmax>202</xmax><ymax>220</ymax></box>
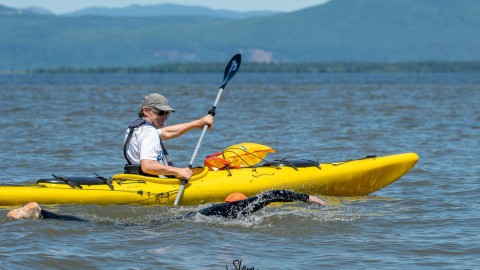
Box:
<box><xmin>7</xmin><ymin>190</ymin><xmax>327</xmax><ymax>221</ymax></box>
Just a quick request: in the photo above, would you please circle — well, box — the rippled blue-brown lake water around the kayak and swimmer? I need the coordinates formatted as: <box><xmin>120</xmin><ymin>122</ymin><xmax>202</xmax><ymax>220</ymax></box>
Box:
<box><xmin>0</xmin><ymin>73</ymin><xmax>480</xmax><ymax>269</ymax></box>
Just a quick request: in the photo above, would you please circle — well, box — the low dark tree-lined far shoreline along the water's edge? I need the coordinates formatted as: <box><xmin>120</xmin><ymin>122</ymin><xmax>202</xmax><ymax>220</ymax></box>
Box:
<box><xmin>0</xmin><ymin>61</ymin><xmax>480</xmax><ymax>74</ymax></box>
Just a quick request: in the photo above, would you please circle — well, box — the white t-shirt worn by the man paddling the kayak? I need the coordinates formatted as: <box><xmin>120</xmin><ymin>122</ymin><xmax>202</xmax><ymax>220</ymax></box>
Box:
<box><xmin>124</xmin><ymin>125</ymin><xmax>167</xmax><ymax>165</ymax></box>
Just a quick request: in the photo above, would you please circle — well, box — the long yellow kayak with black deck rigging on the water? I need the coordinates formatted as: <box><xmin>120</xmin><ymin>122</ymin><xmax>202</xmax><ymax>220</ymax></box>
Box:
<box><xmin>0</xmin><ymin>153</ymin><xmax>418</xmax><ymax>206</ymax></box>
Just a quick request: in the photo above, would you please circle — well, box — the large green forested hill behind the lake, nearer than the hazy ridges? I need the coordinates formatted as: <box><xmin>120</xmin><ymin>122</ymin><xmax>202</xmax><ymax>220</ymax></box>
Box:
<box><xmin>0</xmin><ymin>0</ymin><xmax>480</xmax><ymax>70</ymax></box>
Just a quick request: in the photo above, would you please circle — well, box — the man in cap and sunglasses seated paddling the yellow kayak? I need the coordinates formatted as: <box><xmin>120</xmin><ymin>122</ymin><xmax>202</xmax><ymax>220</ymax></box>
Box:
<box><xmin>123</xmin><ymin>93</ymin><xmax>213</xmax><ymax>179</ymax></box>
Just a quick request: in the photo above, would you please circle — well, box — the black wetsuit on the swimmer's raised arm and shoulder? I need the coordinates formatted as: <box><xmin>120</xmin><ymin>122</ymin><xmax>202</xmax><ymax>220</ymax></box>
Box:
<box><xmin>187</xmin><ymin>190</ymin><xmax>309</xmax><ymax>219</ymax></box>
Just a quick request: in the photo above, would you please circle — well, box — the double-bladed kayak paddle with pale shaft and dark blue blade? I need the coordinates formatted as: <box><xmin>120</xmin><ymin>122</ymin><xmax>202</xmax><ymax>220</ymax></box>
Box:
<box><xmin>173</xmin><ymin>54</ymin><xmax>242</xmax><ymax>206</ymax></box>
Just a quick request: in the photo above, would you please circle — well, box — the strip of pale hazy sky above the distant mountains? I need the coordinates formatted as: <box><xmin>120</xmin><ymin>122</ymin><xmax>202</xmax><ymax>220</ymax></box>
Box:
<box><xmin>0</xmin><ymin>0</ymin><xmax>329</xmax><ymax>14</ymax></box>
